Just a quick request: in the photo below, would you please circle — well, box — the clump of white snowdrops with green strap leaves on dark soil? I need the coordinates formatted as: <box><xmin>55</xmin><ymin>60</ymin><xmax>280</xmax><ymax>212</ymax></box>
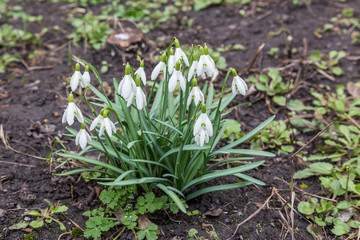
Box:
<box><xmin>56</xmin><ymin>38</ymin><xmax>274</xmax><ymax>212</ymax></box>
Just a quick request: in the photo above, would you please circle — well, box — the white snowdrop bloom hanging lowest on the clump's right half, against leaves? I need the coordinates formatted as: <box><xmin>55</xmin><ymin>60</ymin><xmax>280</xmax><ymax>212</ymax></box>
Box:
<box><xmin>193</xmin><ymin>104</ymin><xmax>213</xmax><ymax>147</ymax></box>
